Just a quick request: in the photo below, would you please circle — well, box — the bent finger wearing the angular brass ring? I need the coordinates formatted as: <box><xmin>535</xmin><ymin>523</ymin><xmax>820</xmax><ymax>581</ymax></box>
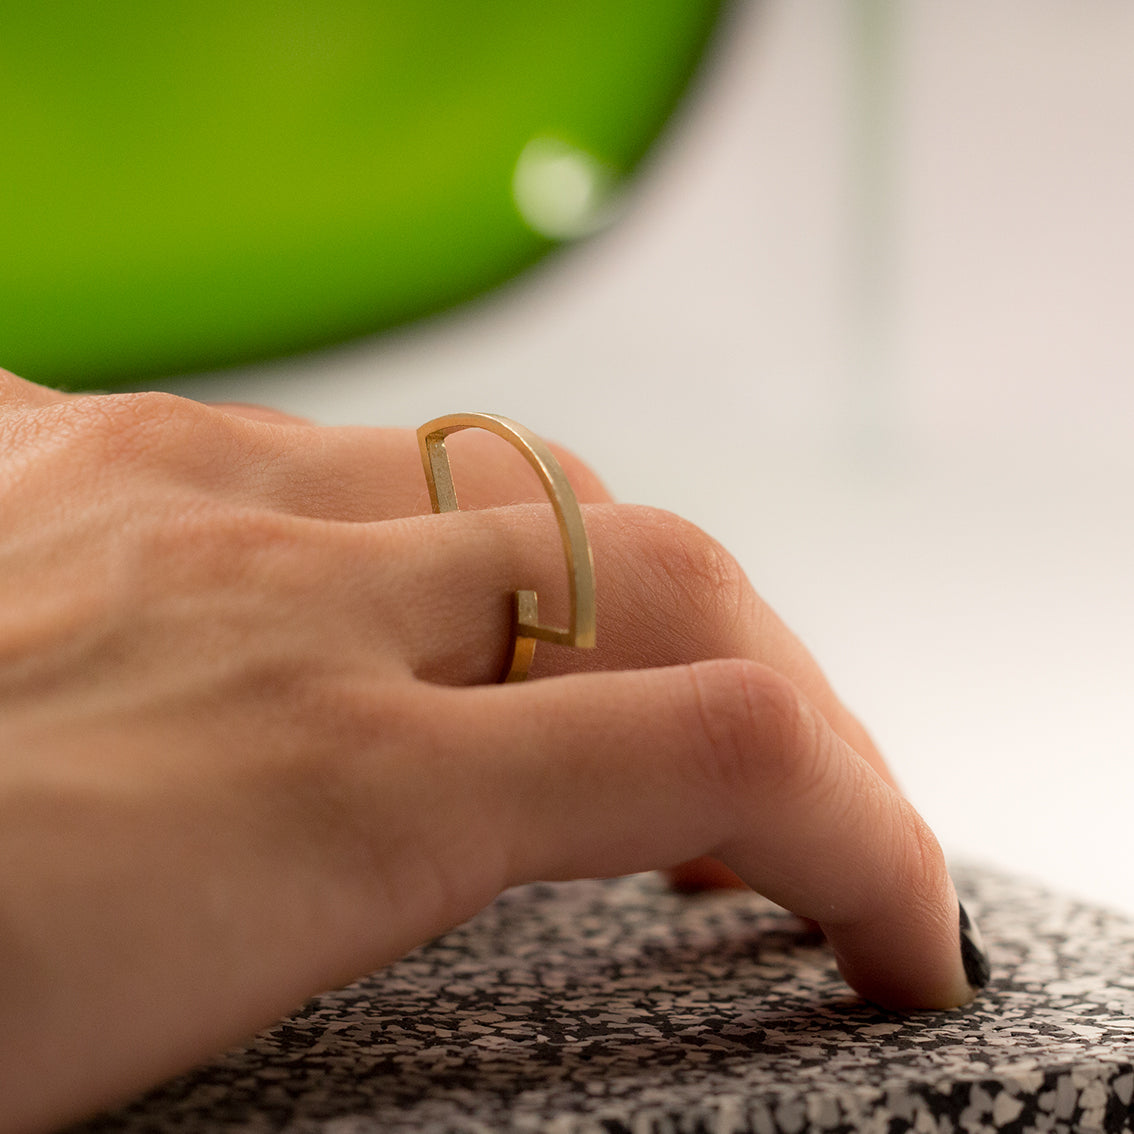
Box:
<box><xmin>367</xmin><ymin>505</ymin><xmax>890</xmax><ymax>781</ymax></box>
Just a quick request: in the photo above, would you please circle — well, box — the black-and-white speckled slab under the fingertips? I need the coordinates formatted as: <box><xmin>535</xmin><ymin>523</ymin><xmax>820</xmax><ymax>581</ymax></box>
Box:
<box><xmin>76</xmin><ymin>868</ymin><xmax>1134</xmax><ymax>1134</ymax></box>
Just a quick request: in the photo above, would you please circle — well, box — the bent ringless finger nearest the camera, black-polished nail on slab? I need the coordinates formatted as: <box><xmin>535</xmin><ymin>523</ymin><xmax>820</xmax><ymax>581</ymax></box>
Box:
<box><xmin>405</xmin><ymin>661</ymin><xmax>987</xmax><ymax>1009</ymax></box>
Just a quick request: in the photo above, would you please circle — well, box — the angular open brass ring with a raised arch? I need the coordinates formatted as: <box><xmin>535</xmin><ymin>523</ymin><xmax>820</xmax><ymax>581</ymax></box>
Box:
<box><xmin>417</xmin><ymin>414</ymin><xmax>594</xmax><ymax>682</ymax></box>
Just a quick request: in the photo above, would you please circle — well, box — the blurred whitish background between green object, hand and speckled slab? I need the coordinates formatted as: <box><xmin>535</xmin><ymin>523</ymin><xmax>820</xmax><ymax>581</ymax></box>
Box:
<box><xmin>157</xmin><ymin>0</ymin><xmax>1134</xmax><ymax>913</ymax></box>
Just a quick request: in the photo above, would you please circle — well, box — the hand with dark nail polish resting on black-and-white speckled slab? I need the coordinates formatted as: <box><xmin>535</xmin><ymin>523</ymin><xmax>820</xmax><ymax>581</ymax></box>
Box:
<box><xmin>0</xmin><ymin>372</ymin><xmax>974</xmax><ymax>1129</ymax></box>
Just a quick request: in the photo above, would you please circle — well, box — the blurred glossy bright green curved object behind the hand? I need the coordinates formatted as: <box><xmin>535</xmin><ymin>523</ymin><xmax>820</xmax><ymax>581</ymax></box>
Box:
<box><xmin>0</xmin><ymin>0</ymin><xmax>721</xmax><ymax>388</ymax></box>
